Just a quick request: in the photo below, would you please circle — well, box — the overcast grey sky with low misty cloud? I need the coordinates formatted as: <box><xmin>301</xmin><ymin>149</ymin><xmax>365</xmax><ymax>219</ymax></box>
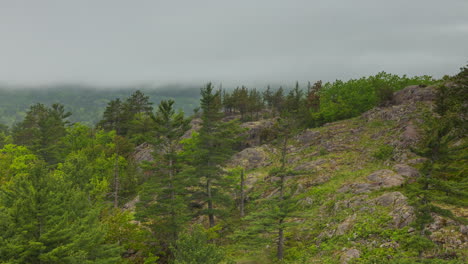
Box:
<box><xmin>0</xmin><ymin>0</ymin><xmax>468</xmax><ymax>86</ymax></box>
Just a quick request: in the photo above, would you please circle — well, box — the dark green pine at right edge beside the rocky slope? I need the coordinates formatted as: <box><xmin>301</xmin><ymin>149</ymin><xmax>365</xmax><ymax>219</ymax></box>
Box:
<box><xmin>408</xmin><ymin>65</ymin><xmax>468</xmax><ymax>233</ymax></box>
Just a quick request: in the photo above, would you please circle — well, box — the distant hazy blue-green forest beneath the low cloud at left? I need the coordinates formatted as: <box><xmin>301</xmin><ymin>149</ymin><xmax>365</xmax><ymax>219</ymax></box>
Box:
<box><xmin>0</xmin><ymin>84</ymin><xmax>199</xmax><ymax>125</ymax></box>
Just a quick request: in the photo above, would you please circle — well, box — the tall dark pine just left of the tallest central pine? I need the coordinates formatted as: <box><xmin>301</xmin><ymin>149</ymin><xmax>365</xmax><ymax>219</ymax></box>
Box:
<box><xmin>138</xmin><ymin>100</ymin><xmax>189</xmax><ymax>248</ymax></box>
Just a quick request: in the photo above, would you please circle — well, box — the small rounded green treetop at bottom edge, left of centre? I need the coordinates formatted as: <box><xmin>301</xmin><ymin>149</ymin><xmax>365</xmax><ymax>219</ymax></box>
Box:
<box><xmin>172</xmin><ymin>225</ymin><xmax>224</xmax><ymax>264</ymax></box>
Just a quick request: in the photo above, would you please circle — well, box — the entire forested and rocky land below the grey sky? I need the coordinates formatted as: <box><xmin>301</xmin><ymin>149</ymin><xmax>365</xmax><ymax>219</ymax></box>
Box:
<box><xmin>0</xmin><ymin>67</ymin><xmax>468</xmax><ymax>264</ymax></box>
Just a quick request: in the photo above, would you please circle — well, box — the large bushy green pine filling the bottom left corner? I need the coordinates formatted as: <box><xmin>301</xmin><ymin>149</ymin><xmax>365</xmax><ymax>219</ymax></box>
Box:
<box><xmin>0</xmin><ymin>161</ymin><xmax>120</xmax><ymax>263</ymax></box>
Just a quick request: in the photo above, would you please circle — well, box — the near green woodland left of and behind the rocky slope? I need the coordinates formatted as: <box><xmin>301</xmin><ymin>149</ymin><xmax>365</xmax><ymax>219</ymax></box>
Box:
<box><xmin>0</xmin><ymin>69</ymin><xmax>466</xmax><ymax>263</ymax></box>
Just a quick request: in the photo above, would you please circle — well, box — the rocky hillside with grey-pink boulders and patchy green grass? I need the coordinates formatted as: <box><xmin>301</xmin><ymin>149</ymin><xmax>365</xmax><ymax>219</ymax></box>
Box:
<box><xmin>222</xmin><ymin>86</ymin><xmax>468</xmax><ymax>263</ymax></box>
